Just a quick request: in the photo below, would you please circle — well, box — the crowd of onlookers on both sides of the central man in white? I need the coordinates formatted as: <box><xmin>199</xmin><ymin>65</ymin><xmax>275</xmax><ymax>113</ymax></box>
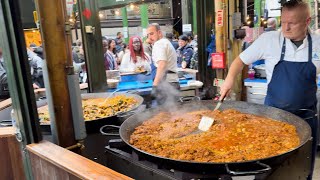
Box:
<box><xmin>102</xmin><ymin>32</ymin><xmax>197</xmax><ymax>72</ymax></box>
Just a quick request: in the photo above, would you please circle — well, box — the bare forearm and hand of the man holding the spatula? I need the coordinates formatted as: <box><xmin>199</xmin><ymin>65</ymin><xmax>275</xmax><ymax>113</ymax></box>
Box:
<box><xmin>220</xmin><ymin>56</ymin><xmax>245</xmax><ymax>99</ymax></box>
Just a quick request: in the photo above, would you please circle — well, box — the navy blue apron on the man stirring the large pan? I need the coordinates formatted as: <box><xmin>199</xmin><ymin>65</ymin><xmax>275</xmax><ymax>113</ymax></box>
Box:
<box><xmin>265</xmin><ymin>34</ymin><xmax>318</xmax><ymax>179</ymax></box>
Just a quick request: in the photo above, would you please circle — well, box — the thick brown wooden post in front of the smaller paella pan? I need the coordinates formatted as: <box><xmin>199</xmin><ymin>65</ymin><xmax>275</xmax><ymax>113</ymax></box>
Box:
<box><xmin>36</xmin><ymin>0</ymin><xmax>76</xmax><ymax>147</ymax></box>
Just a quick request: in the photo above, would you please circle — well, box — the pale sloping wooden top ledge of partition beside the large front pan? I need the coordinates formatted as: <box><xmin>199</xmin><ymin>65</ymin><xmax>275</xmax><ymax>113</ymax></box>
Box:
<box><xmin>27</xmin><ymin>141</ymin><xmax>131</xmax><ymax>179</ymax></box>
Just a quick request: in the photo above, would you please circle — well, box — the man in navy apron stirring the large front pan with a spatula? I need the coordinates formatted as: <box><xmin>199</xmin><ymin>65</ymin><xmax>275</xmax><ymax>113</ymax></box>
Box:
<box><xmin>220</xmin><ymin>0</ymin><xmax>320</xmax><ymax>179</ymax></box>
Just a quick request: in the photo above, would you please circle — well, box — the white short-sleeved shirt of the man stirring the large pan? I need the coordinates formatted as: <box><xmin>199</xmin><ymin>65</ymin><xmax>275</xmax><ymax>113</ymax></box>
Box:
<box><xmin>240</xmin><ymin>31</ymin><xmax>320</xmax><ymax>83</ymax></box>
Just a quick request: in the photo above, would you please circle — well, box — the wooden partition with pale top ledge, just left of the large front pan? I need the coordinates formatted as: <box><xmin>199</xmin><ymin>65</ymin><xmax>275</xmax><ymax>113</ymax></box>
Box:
<box><xmin>27</xmin><ymin>141</ymin><xmax>131</xmax><ymax>180</ymax></box>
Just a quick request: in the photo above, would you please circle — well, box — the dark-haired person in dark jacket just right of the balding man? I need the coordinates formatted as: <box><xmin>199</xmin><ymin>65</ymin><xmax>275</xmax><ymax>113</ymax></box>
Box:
<box><xmin>177</xmin><ymin>35</ymin><xmax>193</xmax><ymax>69</ymax></box>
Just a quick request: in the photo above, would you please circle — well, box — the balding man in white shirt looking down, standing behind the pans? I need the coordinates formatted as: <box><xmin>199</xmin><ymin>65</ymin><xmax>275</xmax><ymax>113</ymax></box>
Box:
<box><xmin>147</xmin><ymin>23</ymin><xmax>180</xmax><ymax>104</ymax></box>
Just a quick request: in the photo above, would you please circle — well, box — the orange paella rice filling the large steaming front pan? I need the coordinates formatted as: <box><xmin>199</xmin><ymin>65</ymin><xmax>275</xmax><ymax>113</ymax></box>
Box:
<box><xmin>129</xmin><ymin>109</ymin><xmax>300</xmax><ymax>163</ymax></box>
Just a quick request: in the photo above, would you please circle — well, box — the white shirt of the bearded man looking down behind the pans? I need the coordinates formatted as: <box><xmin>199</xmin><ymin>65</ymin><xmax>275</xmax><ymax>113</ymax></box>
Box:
<box><xmin>152</xmin><ymin>38</ymin><xmax>178</xmax><ymax>72</ymax></box>
